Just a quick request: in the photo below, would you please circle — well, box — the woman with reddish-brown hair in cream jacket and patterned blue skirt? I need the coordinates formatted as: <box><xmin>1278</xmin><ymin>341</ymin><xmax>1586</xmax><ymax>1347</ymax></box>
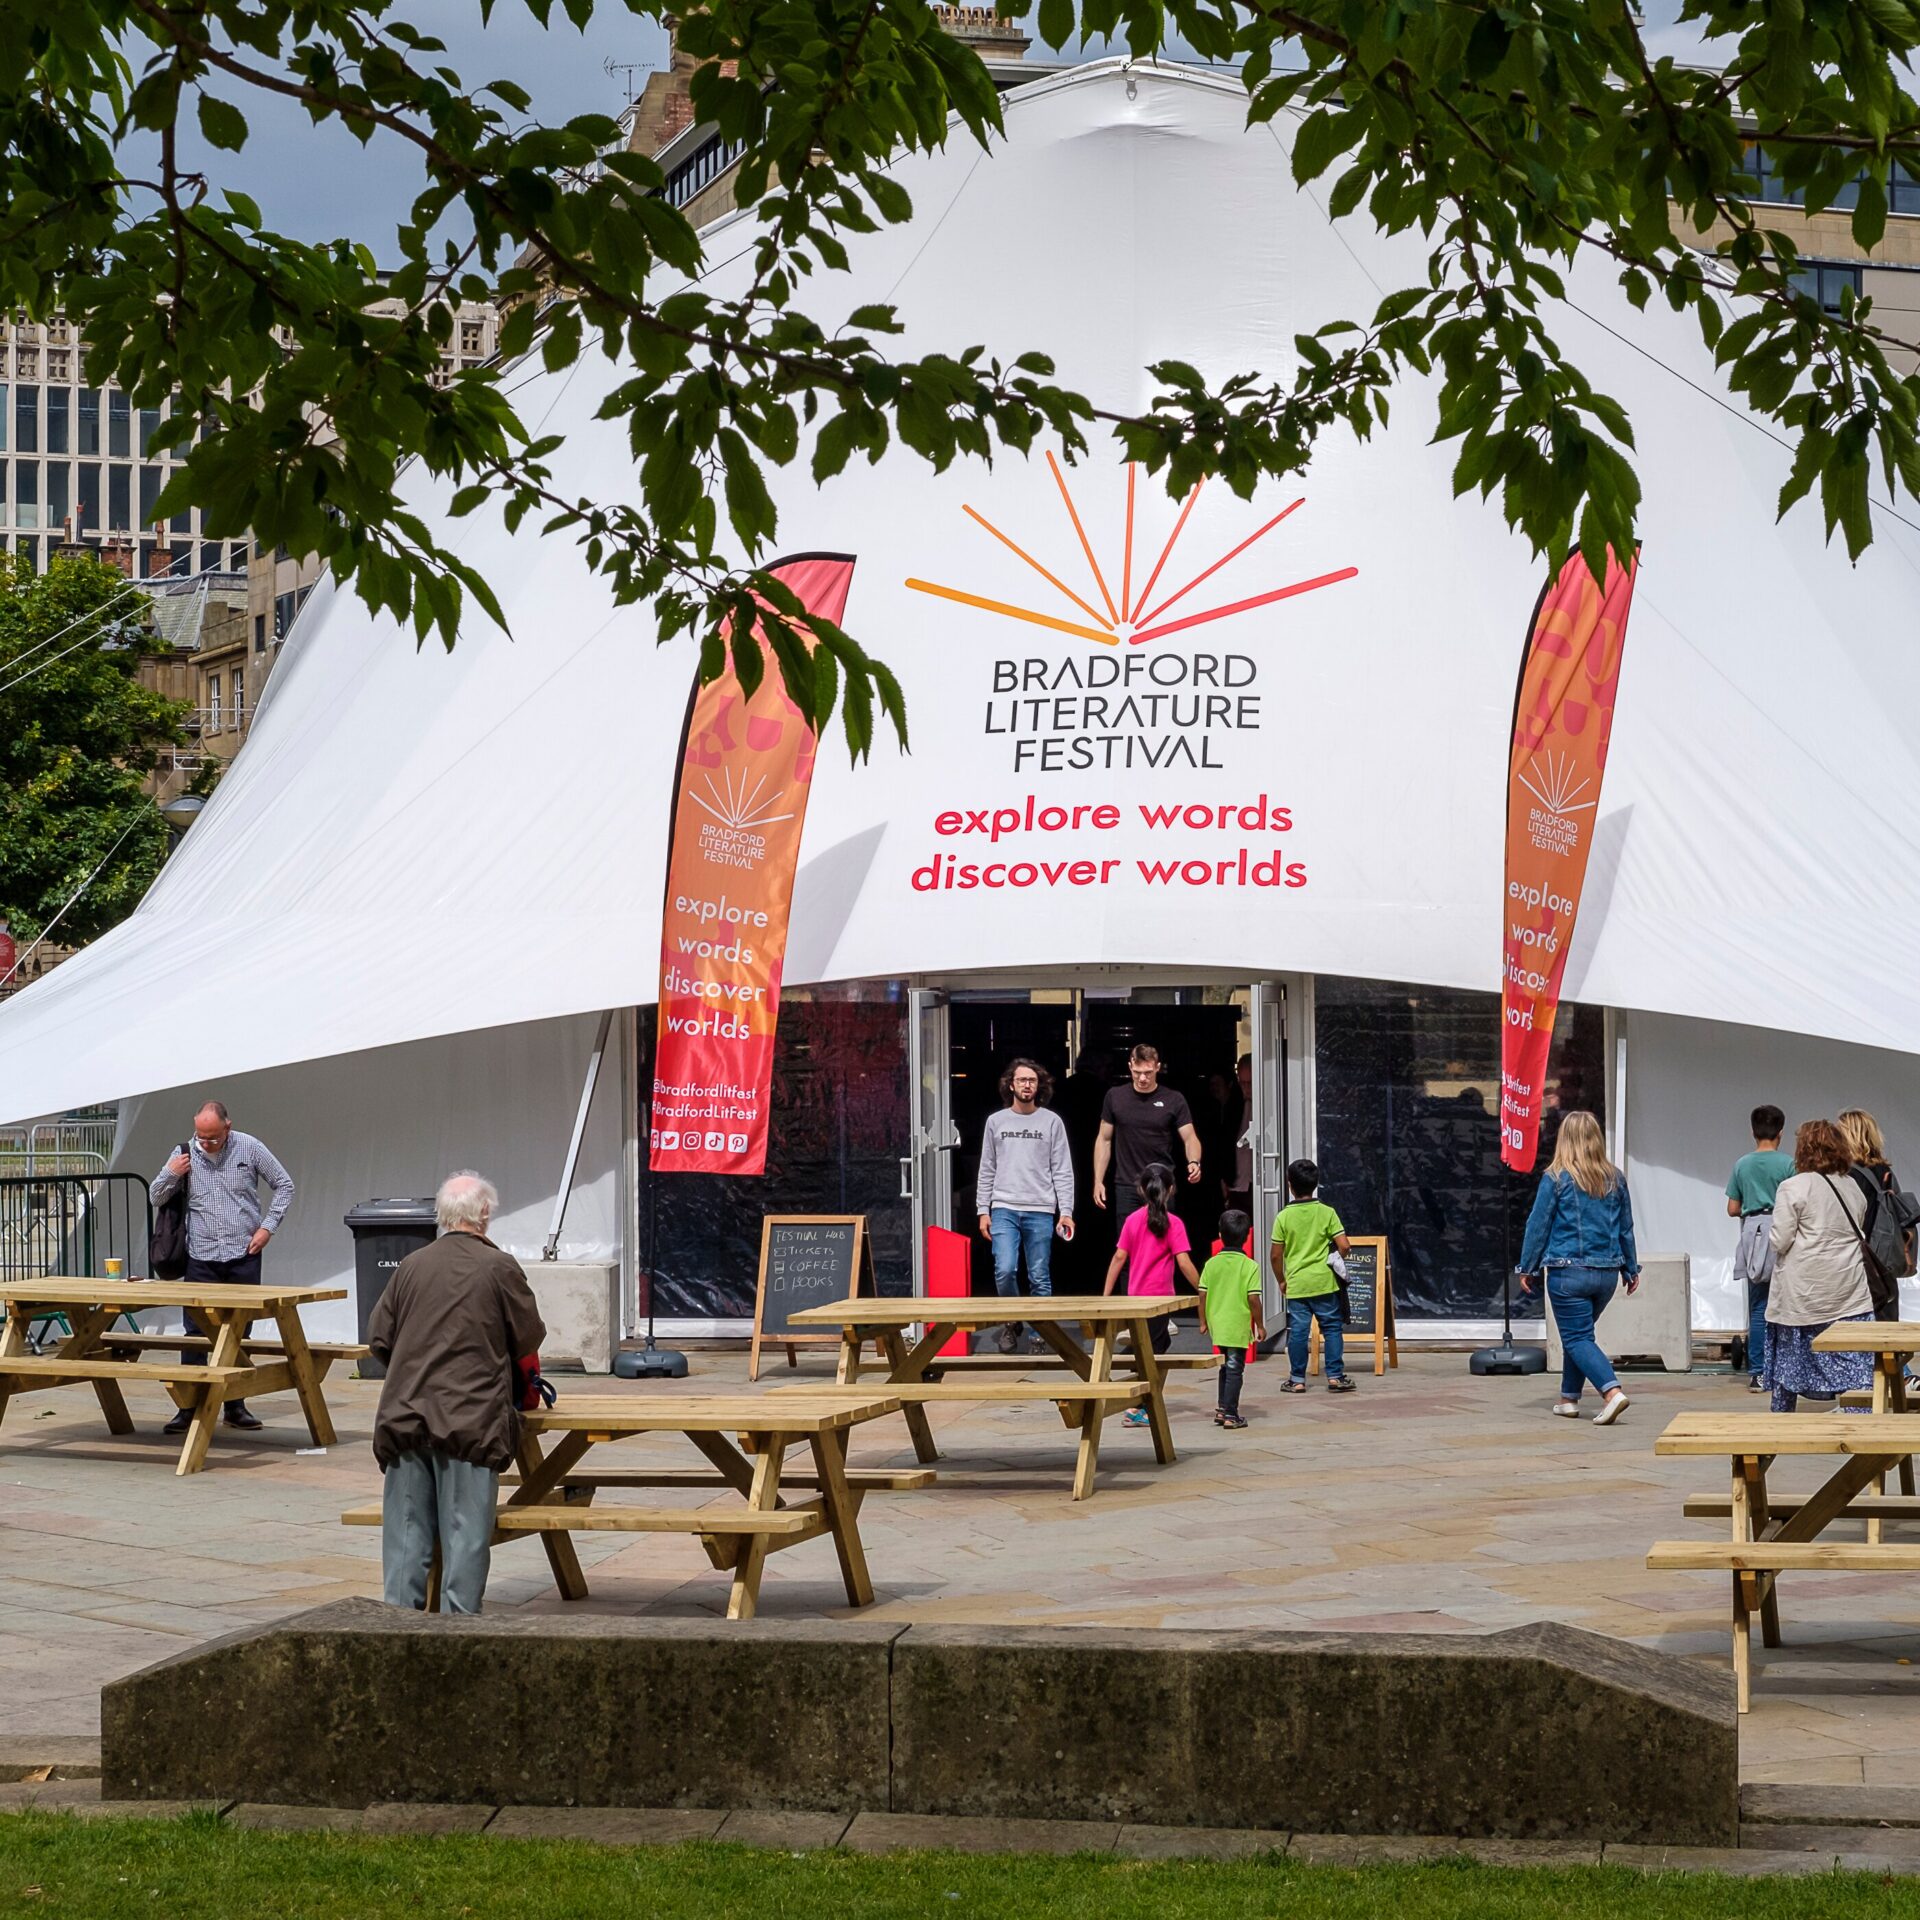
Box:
<box><xmin>1766</xmin><ymin>1119</ymin><xmax>1874</xmax><ymax>1413</ymax></box>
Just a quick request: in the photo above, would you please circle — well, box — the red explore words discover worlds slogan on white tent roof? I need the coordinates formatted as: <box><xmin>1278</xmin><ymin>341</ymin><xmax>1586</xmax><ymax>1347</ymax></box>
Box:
<box><xmin>910</xmin><ymin>793</ymin><xmax>1308</xmax><ymax>893</ymax></box>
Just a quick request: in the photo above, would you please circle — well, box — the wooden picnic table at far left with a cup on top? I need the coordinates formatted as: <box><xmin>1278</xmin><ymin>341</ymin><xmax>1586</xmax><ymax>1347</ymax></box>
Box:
<box><xmin>0</xmin><ymin>1275</ymin><xmax>367</xmax><ymax>1473</ymax></box>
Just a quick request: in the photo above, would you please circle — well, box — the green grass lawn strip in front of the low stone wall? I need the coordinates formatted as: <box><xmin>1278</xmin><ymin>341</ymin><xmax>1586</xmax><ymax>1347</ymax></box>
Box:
<box><xmin>0</xmin><ymin>1812</ymin><xmax>1920</xmax><ymax>1920</ymax></box>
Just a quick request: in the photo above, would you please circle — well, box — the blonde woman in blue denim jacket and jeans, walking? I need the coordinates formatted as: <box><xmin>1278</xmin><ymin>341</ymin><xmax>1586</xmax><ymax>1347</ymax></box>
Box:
<box><xmin>1521</xmin><ymin>1112</ymin><xmax>1640</xmax><ymax>1427</ymax></box>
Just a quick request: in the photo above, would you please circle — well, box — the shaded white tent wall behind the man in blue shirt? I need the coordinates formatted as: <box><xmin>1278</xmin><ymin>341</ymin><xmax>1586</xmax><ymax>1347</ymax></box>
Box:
<box><xmin>115</xmin><ymin>1016</ymin><xmax>626</xmax><ymax>1340</ymax></box>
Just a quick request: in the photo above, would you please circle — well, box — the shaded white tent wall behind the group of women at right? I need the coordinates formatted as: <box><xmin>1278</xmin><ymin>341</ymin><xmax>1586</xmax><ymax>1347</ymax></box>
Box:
<box><xmin>1622</xmin><ymin>1014</ymin><xmax>1920</xmax><ymax>1329</ymax></box>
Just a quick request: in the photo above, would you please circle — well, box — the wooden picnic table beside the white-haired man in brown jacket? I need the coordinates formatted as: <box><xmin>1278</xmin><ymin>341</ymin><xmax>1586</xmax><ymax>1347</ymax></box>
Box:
<box><xmin>340</xmin><ymin>1388</ymin><xmax>913</xmax><ymax>1620</ymax></box>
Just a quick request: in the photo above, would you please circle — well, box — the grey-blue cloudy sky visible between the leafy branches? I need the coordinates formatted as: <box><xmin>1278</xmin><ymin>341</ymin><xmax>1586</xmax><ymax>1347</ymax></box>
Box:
<box><xmin>142</xmin><ymin>0</ymin><xmax>1699</xmax><ymax>263</ymax></box>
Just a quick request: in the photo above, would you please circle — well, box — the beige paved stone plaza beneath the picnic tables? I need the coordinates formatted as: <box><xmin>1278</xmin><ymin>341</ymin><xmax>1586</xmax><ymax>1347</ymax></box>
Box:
<box><xmin>0</xmin><ymin>1354</ymin><xmax>1920</xmax><ymax>1786</ymax></box>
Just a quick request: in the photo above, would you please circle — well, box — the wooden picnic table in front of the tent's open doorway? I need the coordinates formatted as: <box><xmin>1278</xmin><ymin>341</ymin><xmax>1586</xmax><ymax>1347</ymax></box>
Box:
<box><xmin>780</xmin><ymin>1294</ymin><xmax>1219</xmax><ymax>1500</ymax></box>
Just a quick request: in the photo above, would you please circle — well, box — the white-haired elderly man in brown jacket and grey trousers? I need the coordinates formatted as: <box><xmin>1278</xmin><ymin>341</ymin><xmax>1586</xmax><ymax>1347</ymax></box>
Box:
<box><xmin>367</xmin><ymin>1173</ymin><xmax>547</xmax><ymax>1613</ymax></box>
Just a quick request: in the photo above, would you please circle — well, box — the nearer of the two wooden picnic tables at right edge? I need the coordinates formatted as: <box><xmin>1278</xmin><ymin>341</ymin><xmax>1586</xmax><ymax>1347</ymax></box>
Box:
<box><xmin>1647</xmin><ymin>1413</ymin><xmax>1920</xmax><ymax>1713</ymax></box>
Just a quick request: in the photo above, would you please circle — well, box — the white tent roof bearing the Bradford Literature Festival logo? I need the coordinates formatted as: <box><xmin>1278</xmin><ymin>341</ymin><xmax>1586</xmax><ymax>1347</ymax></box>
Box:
<box><xmin>0</xmin><ymin>63</ymin><xmax>1920</xmax><ymax>1116</ymax></box>
